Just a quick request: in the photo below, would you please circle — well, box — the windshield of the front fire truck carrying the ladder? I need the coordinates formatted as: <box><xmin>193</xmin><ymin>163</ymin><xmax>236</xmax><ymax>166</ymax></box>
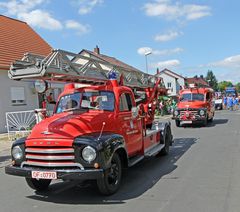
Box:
<box><xmin>56</xmin><ymin>91</ymin><xmax>115</xmax><ymax>113</ymax></box>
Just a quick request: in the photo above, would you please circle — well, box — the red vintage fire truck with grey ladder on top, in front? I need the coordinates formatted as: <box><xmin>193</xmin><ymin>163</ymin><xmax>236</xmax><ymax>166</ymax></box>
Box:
<box><xmin>5</xmin><ymin>50</ymin><xmax>173</xmax><ymax>195</ymax></box>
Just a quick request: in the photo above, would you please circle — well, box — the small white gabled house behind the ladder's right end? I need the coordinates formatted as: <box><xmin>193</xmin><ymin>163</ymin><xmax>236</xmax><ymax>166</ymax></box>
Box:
<box><xmin>156</xmin><ymin>69</ymin><xmax>185</xmax><ymax>97</ymax></box>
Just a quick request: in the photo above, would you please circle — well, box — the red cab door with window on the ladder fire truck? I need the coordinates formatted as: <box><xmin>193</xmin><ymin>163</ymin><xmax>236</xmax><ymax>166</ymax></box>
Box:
<box><xmin>118</xmin><ymin>92</ymin><xmax>143</xmax><ymax>156</ymax></box>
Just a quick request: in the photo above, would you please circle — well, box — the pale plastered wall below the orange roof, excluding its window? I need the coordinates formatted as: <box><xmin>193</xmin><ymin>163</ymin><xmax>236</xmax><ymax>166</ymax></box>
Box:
<box><xmin>0</xmin><ymin>70</ymin><xmax>38</xmax><ymax>133</ymax></box>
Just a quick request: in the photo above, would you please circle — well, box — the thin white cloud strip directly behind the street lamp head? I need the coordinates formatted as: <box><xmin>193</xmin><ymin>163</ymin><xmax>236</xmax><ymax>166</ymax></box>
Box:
<box><xmin>137</xmin><ymin>47</ymin><xmax>183</xmax><ymax>56</ymax></box>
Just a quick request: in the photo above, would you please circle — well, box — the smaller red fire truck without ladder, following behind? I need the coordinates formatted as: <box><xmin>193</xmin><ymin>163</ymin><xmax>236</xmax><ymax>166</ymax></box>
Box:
<box><xmin>173</xmin><ymin>84</ymin><xmax>215</xmax><ymax>127</ymax></box>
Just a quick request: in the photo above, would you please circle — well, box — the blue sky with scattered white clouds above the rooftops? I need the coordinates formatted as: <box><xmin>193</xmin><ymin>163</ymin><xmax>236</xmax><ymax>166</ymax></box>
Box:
<box><xmin>0</xmin><ymin>0</ymin><xmax>240</xmax><ymax>83</ymax></box>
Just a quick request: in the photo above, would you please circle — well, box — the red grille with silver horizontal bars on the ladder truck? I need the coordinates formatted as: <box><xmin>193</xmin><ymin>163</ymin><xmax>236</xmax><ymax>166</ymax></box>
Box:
<box><xmin>21</xmin><ymin>147</ymin><xmax>83</xmax><ymax>169</ymax></box>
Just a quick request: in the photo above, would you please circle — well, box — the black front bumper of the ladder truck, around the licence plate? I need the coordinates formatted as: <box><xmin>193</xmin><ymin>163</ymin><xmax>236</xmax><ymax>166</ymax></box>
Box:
<box><xmin>5</xmin><ymin>165</ymin><xmax>103</xmax><ymax>180</ymax></box>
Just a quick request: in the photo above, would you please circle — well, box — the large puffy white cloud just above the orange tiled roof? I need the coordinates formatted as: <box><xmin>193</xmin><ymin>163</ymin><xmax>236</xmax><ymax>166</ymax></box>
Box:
<box><xmin>18</xmin><ymin>10</ymin><xmax>63</xmax><ymax>30</ymax></box>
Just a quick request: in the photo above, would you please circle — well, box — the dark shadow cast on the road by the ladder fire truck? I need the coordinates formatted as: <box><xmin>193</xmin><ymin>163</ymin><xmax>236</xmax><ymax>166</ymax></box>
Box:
<box><xmin>27</xmin><ymin>138</ymin><xmax>197</xmax><ymax>205</ymax></box>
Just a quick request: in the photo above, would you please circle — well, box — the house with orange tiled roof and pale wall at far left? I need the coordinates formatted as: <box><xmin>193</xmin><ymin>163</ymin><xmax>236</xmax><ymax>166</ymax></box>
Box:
<box><xmin>0</xmin><ymin>15</ymin><xmax>52</xmax><ymax>133</ymax></box>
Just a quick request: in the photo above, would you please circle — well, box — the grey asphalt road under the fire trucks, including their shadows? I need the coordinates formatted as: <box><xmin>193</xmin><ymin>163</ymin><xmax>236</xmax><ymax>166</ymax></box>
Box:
<box><xmin>0</xmin><ymin>111</ymin><xmax>240</xmax><ymax>212</ymax></box>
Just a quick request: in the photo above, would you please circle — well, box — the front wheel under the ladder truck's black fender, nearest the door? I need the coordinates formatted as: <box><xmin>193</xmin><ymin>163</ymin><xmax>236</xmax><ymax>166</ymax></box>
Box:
<box><xmin>97</xmin><ymin>153</ymin><xmax>122</xmax><ymax>195</ymax></box>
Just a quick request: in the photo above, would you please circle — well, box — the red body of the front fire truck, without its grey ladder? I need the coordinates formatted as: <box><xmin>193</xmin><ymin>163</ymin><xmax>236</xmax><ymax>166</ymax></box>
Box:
<box><xmin>5</xmin><ymin>49</ymin><xmax>172</xmax><ymax>195</ymax></box>
